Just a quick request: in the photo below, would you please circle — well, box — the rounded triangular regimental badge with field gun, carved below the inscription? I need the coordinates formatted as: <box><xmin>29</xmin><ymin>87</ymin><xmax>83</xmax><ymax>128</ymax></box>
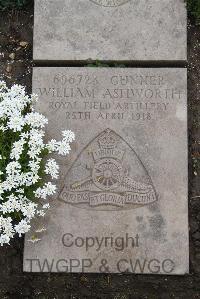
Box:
<box><xmin>59</xmin><ymin>129</ymin><xmax>157</xmax><ymax>210</ymax></box>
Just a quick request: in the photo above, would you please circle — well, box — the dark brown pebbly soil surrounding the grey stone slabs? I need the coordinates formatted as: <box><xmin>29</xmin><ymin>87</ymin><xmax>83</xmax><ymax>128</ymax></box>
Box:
<box><xmin>0</xmin><ymin>7</ymin><xmax>200</xmax><ymax>299</ymax></box>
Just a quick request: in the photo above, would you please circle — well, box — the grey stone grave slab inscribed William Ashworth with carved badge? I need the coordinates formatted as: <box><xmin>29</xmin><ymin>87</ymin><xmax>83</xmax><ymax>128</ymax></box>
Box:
<box><xmin>24</xmin><ymin>68</ymin><xmax>189</xmax><ymax>274</ymax></box>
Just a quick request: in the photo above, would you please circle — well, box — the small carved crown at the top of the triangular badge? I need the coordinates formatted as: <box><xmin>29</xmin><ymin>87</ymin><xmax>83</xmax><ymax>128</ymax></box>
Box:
<box><xmin>98</xmin><ymin>129</ymin><xmax>119</xmax><ymax>149</ymax></box>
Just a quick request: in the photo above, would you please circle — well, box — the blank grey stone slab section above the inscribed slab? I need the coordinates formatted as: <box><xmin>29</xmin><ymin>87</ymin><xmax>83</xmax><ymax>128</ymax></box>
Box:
<box><xmin>33</xmin><ymin>0</ymin><xmax>187</xmax><ymax>61</ymax></box>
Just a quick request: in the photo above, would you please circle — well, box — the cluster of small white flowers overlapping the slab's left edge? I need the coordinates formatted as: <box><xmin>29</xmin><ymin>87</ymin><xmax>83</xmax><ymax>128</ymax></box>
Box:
<box><xmin>0</xmin><ymin>81</ymin><xmax>75</xmax><ymax>245</ymax></box>
